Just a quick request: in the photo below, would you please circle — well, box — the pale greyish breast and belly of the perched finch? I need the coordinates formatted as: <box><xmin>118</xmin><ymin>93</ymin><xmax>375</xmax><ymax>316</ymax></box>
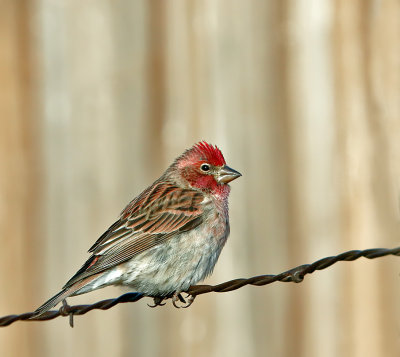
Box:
<box><xmin>115</xmin><ymin>204</ymin><xmax>229</xmax><ymax>296</ymax></box>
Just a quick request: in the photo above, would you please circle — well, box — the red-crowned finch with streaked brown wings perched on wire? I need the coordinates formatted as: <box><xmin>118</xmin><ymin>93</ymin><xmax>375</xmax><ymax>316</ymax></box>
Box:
<box><xmin>32</xmin><ymin>141</ymin><xmax>242</xmax><ymax>317</ymax></box>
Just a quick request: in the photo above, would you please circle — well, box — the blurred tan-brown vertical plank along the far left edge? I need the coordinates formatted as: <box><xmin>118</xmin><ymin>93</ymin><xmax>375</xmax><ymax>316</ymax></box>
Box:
<box><xmin>0</xmin><ymin>0</ymin><xmax>42</xmax><ymax>356</ymax></box>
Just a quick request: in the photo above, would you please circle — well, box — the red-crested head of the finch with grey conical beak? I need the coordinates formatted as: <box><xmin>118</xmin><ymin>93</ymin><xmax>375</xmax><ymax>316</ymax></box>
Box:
<box><xmin>174</xmin><ymin>141</ymin><xmax>242</xmax><ymax>194</ymax></box>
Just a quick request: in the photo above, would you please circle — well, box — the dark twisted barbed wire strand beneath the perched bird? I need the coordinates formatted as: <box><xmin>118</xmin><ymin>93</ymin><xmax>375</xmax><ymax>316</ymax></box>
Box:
<box><xmin>0</xmin><ymin>247</ymin><xmax>400</xmax><ymax>327</ymax></box>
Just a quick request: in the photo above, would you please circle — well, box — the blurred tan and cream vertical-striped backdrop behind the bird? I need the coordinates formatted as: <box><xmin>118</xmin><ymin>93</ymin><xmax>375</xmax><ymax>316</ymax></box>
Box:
<box><xmin>0</xmin><ymin>0</ymin><xmax>400</xmax><ymax>357</ymax></box>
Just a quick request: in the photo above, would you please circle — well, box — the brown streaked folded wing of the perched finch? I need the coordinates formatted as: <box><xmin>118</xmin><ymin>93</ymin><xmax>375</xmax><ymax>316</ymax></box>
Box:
<box><xmin>64</xmin><ymin>182</ymin><xmax>204</xmax><ymax>288</ymax></box>
